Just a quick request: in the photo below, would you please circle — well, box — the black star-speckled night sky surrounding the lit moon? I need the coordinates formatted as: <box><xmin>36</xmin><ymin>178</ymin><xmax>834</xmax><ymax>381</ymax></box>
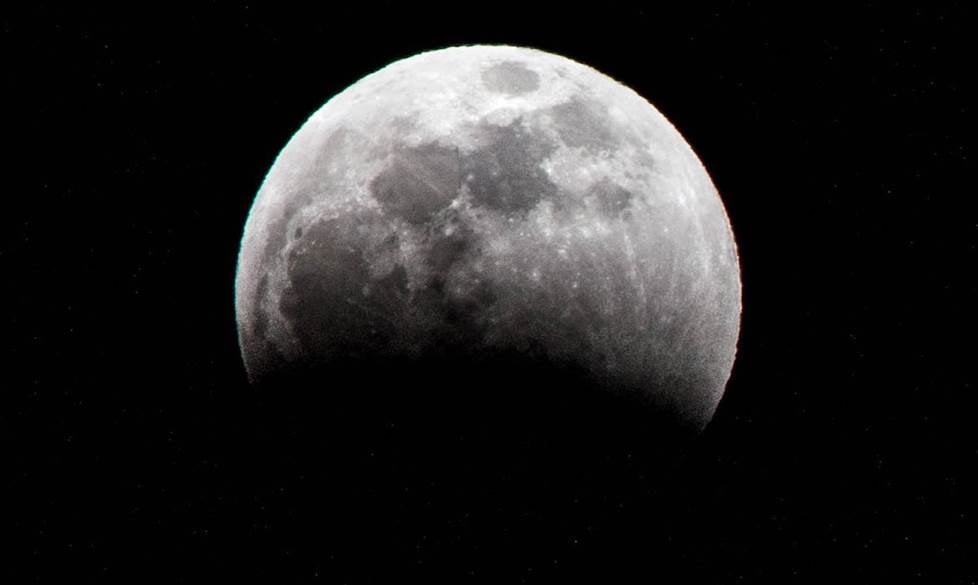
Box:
<box><xmin>0</xmin><ymin>2</ymin><xmax>978</xmax><ymax>583</ymax></box>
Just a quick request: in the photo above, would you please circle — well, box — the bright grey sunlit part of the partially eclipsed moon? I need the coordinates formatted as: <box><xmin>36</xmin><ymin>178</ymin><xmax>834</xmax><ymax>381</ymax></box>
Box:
<box><xmin>235</xmin><ymin>46</ymin><xmax>741</xmax><ymax>429</ymax></box>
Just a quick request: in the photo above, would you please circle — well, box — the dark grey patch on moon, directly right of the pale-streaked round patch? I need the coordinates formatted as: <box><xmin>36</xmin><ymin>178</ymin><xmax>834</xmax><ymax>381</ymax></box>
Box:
<box><xmin>462</xmin><ymin>120</ymin><xmax>558</xmax><ymax>213</ymax></box>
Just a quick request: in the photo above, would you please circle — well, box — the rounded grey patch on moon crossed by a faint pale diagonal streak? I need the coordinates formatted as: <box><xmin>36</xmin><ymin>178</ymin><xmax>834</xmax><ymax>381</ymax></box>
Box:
<box><xmin>370</xmin><ymin>142</ymin><xmax>461</xmax><ymax>224</ymax></box>
